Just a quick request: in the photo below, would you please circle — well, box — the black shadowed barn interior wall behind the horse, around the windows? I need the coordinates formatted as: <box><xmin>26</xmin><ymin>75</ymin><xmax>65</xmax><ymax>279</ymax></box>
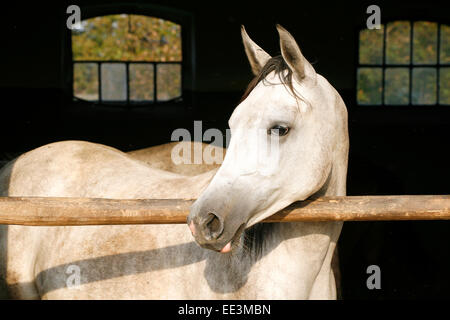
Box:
<box><xmin>0</xmin><ymin>1</ymin><xmax>450</xmax><ymax>298</ymax></box>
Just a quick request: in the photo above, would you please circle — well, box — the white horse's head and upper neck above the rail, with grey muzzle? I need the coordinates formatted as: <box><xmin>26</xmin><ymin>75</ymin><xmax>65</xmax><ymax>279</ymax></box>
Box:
<box><xmin>188</xmin><ymin>25</ymin><xmax>348</xmax><ymax>252</ymax></box>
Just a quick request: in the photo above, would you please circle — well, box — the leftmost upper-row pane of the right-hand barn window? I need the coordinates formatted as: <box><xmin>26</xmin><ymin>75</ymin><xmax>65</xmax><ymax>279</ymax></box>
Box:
<box><xmin>359</xmin><ymin>25</ymin><xmax>384</xmax><ymax>64</ymax></box>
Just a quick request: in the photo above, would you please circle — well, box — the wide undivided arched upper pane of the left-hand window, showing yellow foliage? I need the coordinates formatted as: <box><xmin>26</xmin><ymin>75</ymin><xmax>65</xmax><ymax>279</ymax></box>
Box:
<box><xmin>72</xmin><ymin>14</ymin><xmax>182</xmax><ymax>61</ymax></box>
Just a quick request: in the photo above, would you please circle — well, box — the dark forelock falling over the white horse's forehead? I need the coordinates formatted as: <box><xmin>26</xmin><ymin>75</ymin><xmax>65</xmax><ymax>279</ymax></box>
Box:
<box><xmin>239</xmin><ymin>55</ymin><xmax>299</xmax><ymax>103</ymax></box>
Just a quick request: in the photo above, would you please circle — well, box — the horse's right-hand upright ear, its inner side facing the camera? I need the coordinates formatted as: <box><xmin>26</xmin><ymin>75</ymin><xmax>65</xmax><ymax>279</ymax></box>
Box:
<box><xmin>277</xmin><ymin>24</ymin><xmax>316</xmax><ymax>81</ymax></box>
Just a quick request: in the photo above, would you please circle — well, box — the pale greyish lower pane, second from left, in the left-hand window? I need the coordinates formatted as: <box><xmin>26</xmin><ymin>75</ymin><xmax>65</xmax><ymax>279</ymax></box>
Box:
<box><xmin>101</xmin><ymin>63</ymin><xmax>127</xmax><ymax>101</ymax></box>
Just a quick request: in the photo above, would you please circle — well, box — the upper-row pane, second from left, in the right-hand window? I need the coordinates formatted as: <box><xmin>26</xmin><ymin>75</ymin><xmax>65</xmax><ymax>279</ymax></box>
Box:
<box><xmin>386</xmin><ymin>21</ymin><xmax>411</xmax><ymax>64</ymax></box>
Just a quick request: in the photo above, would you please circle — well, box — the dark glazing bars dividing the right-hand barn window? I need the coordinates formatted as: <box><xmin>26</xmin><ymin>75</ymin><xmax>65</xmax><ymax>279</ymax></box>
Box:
<box><xmin>357</xmin><ymin>20</ymin><xmax>450</xmax><ymax>106</ymax></box>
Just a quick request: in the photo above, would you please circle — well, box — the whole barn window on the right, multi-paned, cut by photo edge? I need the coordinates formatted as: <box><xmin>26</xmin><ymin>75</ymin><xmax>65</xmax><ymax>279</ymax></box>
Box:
<box><xmin>356</xmin><ymin>21</ymin><xmax>450</xmax><ymax>105</ymax></box>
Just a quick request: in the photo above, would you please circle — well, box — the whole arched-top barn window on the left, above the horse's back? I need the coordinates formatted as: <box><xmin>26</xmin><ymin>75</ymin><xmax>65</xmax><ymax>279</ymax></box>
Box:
<box><xmin>72</xmin><ymin>14</ymin><xmax>182</xmax><ymax>105</ymax></box>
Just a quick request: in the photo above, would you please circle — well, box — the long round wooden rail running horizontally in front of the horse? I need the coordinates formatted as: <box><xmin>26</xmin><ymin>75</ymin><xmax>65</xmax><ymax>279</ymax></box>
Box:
<box><xmin>0</xmin><ymin>195</ymin><xmax>450</xmax><ymax>226</ymax></box>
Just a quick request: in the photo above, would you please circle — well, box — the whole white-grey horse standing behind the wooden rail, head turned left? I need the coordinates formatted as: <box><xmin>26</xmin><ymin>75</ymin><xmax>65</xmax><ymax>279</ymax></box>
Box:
<box><xmin>0</xmin><ymin>26</ymin><xmax>348</xmax><ymax>299</ymax></box>
